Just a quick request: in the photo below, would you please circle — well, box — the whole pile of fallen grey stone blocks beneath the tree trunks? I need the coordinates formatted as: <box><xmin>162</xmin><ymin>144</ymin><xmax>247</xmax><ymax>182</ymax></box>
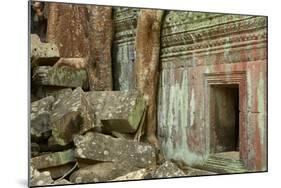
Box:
<box><xmin>30</xmin><ymin>36</ymin><xmax>190</xmax><ymax>186</ymax></box>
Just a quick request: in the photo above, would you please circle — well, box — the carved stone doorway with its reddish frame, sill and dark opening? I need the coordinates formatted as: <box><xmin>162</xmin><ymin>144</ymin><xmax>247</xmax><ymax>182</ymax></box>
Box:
<box><xmin>204</xmin><ymin>71</ymin><xmax>248</xmax><ymax>172</ymax></box>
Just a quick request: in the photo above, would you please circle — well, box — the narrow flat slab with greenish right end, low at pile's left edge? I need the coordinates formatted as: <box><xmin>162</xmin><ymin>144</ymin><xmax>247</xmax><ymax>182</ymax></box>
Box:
<box><xmin>31</xmin><ymin>149</ymin><xmax>75</xmax><ymax>170</ymax></box>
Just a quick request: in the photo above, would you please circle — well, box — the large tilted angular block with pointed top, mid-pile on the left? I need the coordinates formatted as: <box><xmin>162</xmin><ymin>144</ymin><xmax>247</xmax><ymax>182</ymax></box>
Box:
<box><xmin>51</xmin><ymin>88</ymin><xmax>96</xmax><ymax>146</ymax></box>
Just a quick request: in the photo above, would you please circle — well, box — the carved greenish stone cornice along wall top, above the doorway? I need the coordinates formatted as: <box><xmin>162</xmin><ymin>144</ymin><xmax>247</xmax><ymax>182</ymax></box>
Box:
<box><xmin>160</xmin><ymin>12</ymin><xmax>267</xmax><ymax>63</ymax></box>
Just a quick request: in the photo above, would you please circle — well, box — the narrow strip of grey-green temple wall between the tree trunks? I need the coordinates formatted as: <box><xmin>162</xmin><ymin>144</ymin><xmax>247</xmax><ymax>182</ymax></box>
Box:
<box><xmin>112</xmin><ymin>7</ymin><xmax>139</xmax><ymax>91</ymax></box>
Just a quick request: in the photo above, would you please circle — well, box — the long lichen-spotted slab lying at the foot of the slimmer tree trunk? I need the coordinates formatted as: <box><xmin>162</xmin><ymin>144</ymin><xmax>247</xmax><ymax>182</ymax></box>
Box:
<box><xmin>74</xmin><ymin>132</ymin><xmax>156</xmax><ymax>168</ymax></box>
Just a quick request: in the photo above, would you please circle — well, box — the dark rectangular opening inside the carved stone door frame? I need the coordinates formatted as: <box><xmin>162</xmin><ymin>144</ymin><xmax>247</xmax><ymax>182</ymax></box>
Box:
<box><xmin>210</xmin><ymin>84</ymin><xmax>239</xmax><ymax>153</ymax></box>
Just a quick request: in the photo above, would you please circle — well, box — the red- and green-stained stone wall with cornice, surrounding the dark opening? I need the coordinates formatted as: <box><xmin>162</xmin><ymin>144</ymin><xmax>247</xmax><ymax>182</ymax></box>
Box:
<box><xmin>158</xmin><ymin>11</ymin><xmax>267</xmax><ymax>170</ymax></box>
